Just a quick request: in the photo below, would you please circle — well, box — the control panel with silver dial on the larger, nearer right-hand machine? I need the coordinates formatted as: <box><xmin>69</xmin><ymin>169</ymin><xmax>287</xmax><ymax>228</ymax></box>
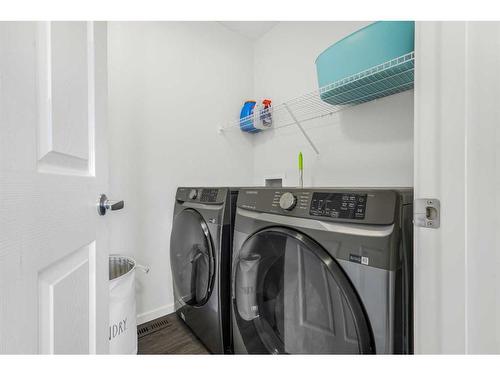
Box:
<box><xmin>237</xmin><ymin>188</ymin><xmax>398</xmax><ymax>224</ymax></box>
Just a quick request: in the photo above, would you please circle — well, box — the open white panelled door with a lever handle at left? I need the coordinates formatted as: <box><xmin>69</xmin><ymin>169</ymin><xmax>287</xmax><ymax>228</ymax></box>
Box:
<box><xmin>0</xmin><ymin>22</ymin><xmax>109</xmax><ymax>353</ymax></box>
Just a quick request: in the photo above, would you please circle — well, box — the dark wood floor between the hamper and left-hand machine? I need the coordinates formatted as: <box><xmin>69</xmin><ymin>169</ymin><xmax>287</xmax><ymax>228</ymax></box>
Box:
<box><xmin>138</xmin><ymin>313</ymin><xmax>210</xmax><ymax>354</ymax></box>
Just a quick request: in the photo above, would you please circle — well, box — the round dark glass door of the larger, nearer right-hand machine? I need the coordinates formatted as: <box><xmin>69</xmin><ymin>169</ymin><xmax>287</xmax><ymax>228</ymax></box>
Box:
<box><xmin>233</xmin><ymin>227</ymin><xmax>375</xmax><ymax>354</ymax></box>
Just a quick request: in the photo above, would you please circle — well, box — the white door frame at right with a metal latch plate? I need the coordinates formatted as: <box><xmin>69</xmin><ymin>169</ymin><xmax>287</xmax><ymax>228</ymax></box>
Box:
<box><xmin>414</xmin><ymin>22</ymin><xmax>500</xmax><ymax>353</ymax></box>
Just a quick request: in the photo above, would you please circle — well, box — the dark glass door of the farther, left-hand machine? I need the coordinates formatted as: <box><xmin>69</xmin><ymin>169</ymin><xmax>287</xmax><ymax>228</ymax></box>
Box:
<box><xmin>170</xmin><ymin>208</ymin><xmax>214</xmax><ymax>306</ymax></box>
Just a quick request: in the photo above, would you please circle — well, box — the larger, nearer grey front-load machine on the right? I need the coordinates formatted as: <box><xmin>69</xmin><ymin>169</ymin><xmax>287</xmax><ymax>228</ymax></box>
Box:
<box><xmin>231</xmin><ymin>188</ymin><xmax>413</xmax><ymax>354</ymax></box>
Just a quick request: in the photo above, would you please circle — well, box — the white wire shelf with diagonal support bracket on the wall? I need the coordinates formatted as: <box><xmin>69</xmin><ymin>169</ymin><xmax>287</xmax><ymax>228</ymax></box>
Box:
<box><xmin>219</xmin><ymin>52</ymin><xmax>415</xmax><ymax>139</ymax></box>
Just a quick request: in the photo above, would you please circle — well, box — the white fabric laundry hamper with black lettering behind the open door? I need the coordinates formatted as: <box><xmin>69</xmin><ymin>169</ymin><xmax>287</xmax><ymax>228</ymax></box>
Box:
<box><xmin>108</xmin><ymin>255</ymin><xmax>149</xmax><ymax>354</ymax></box>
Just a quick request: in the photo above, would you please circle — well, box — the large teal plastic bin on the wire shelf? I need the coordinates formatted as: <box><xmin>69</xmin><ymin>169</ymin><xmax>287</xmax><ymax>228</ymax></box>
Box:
<box><xmin>316</xmin><ymin>21</ymin><xmax>415</xmax><ymax>105</ymax></box>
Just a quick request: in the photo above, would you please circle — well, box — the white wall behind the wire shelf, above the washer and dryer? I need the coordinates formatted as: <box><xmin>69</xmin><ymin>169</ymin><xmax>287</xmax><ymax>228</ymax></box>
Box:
<box><xmin>254</xmin><ymin>22</ymin><xmax>413</xmax><ymax>186</ymax></box>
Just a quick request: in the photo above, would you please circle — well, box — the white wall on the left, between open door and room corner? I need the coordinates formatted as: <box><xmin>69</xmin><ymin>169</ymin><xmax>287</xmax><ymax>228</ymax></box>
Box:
<box><xmin>108</xmin><ymin>22</ymin><xmax>253</xmax><ymax>322</ymax></box>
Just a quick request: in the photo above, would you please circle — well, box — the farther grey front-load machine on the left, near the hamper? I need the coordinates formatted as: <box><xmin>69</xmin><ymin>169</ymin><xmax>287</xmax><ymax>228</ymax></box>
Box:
<box><xmin>170</xmin><ymin>187</ymin><xmax>238</xmax><ymax>353</ymax></box>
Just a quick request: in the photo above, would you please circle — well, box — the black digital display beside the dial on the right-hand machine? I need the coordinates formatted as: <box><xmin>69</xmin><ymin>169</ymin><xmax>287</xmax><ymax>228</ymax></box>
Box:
<box><xmin>309</xmin><ymin>193</ymin><xmax>367</xmax><ymax>220</ymax></box>
